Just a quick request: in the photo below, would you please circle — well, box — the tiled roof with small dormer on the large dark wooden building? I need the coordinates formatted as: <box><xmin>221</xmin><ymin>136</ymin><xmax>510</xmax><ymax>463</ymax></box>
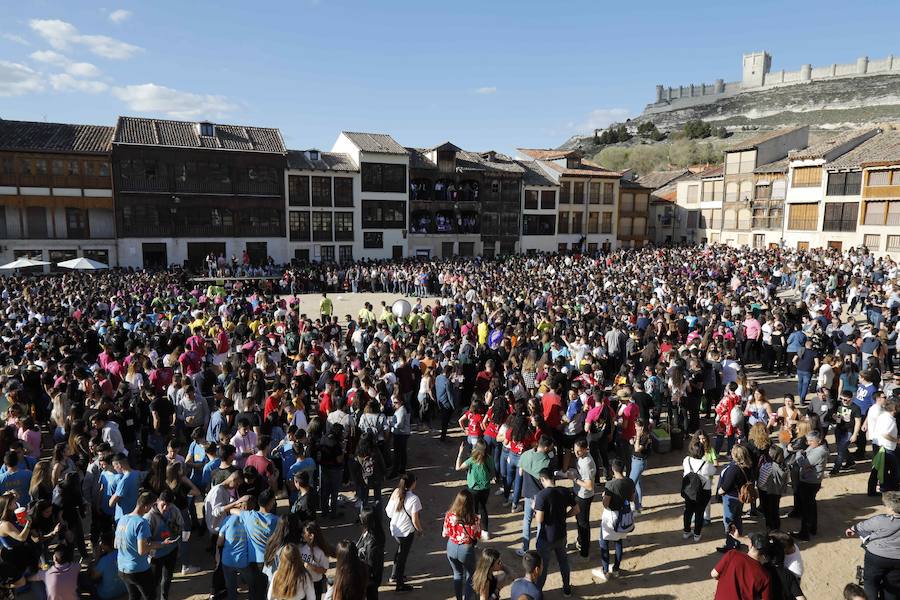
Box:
<box><xmin>113</xmin><ymin>117</ymin><xmax>287</xmax><ymax>154</ymax></box>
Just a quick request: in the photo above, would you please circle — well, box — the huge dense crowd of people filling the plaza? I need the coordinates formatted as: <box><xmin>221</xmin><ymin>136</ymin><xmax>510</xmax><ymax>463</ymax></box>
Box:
<box><xmin>0</xmin><ymin>246</ymin><xmax>900</xmax><ymax>600</ymax></box>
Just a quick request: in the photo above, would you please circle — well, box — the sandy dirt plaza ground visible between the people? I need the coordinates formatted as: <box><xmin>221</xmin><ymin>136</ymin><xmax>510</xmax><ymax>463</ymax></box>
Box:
<box><xmin>163</xmin><ymin>294</ymin><xmax>881</xmax><ymax>600</ymax></box>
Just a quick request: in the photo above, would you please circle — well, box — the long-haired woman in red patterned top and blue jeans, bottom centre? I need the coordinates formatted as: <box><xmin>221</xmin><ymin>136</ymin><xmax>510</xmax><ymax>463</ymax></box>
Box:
<box><xmin>441</xmin><ymin>490</ymin><xmax>481</xmax><ymax>600</ymax></box>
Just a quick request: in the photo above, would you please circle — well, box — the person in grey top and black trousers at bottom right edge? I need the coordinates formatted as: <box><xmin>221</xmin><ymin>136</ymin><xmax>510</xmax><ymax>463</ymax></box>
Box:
<box><xmin>846</xmin><ymin>491</ymin><xmax>900</xmax><ymax>600</ymax></box>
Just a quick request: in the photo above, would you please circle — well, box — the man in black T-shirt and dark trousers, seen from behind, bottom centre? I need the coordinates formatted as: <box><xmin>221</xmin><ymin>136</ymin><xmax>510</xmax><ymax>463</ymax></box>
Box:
<box><xmin>534</xmin><ymin>468</ymin><xmax>578</xmax><ymax>597</ymax></box>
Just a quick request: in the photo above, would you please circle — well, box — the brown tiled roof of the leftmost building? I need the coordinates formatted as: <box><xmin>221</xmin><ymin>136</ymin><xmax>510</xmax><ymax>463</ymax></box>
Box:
<box><xmin>0</xmin><ymin>119</ymin><xmax>113</xmax><ymax>154</ymax></box>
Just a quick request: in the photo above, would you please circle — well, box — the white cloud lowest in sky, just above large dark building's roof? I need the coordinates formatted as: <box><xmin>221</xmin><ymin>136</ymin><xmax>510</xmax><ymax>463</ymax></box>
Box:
<box><xmin>113</xmin><ymin>83</ymin><xmax>236</xmax><ymax>119</ymax></box>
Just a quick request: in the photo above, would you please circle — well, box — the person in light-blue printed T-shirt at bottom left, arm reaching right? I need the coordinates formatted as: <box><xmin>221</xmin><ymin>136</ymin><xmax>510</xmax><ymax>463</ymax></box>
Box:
<box><xmin>115</xmin><ymin>492</ymin><xmax>178</xmax><ymax>600</ymax></box>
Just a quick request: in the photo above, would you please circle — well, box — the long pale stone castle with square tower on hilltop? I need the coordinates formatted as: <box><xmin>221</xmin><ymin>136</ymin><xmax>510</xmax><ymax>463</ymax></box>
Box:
<box><xmin>644</xmin><ymin>52</ymin><xmax>900</xmax><ymax>115</ymax></box>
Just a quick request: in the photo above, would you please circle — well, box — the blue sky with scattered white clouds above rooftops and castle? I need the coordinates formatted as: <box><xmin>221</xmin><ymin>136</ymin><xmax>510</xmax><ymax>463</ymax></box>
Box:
<box><xmin>0</xmin><ymin>0</ymin><xmax>900</xmax><ymax>152</ymax></box>
